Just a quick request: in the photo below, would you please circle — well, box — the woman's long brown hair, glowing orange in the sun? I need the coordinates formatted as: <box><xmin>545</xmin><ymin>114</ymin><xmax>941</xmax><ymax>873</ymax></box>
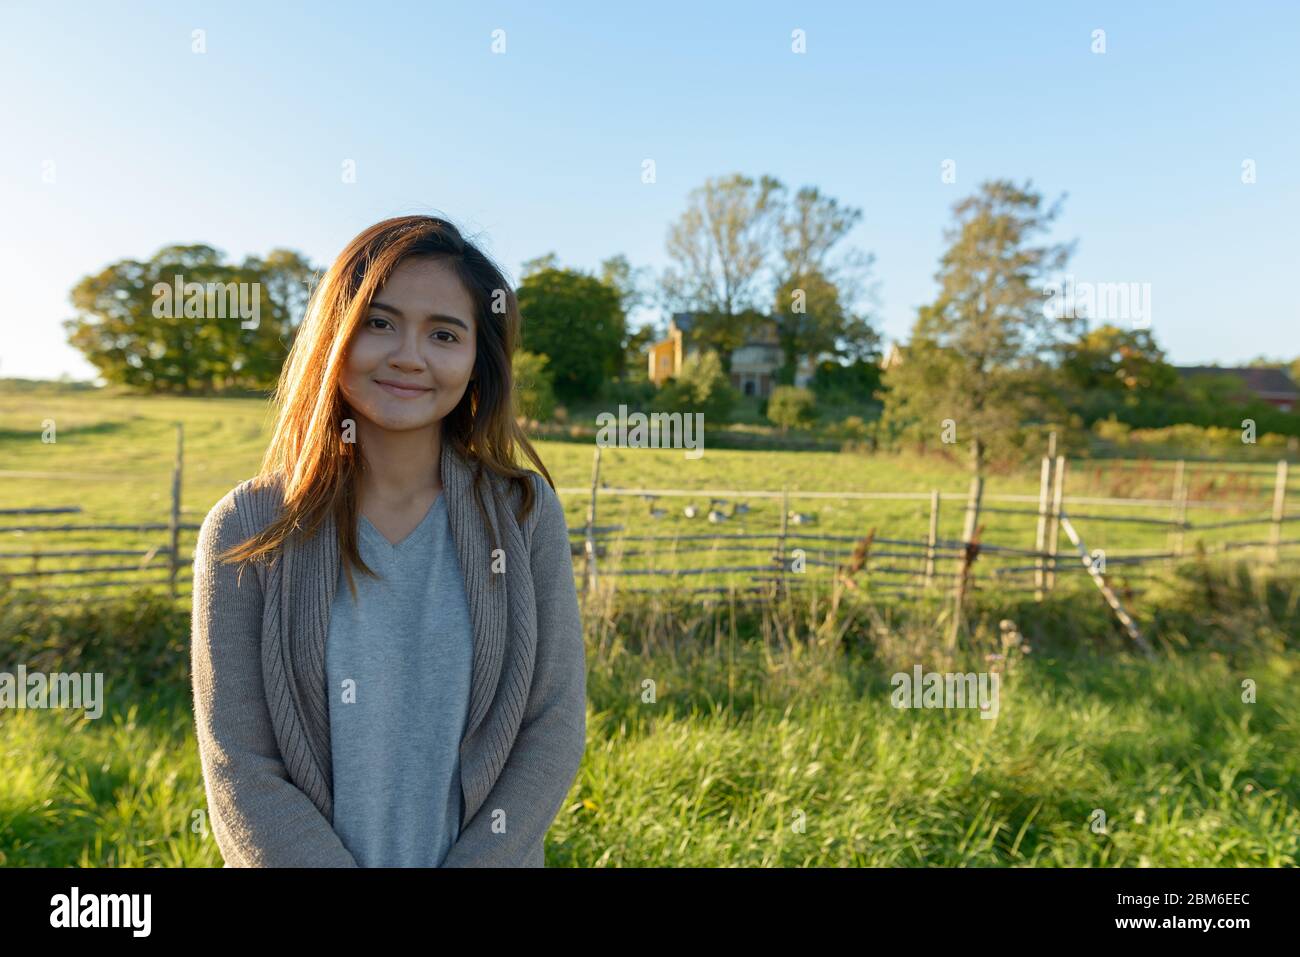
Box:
<box><xmin>218</xmin><ymin>216</ymin><xmax>555</xmax><ymax>597</ymax></box>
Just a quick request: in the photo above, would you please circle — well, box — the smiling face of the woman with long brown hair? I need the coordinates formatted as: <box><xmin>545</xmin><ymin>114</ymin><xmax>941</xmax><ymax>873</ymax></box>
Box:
<box><xmin>339</xmin><ymin>259</ymin><xmax>477</xmax><ymax>432</ymax></box>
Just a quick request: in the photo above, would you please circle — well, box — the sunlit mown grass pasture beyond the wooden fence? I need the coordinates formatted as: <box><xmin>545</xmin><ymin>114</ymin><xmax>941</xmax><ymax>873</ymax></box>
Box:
<box><xmin>0</xmin><ymin>391</ymin><xmax>1300</xmax><ymax>605</ymax></box>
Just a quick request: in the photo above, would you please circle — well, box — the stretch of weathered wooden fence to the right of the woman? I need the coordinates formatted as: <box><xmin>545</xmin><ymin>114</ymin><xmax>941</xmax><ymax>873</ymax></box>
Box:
<box><xmin>558</xmin><ymin>447</ymin><xmax>1300</xmax><ymax>653</ymax></box>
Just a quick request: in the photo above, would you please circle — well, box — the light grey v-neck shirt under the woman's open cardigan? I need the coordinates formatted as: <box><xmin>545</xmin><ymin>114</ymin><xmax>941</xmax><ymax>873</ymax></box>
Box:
<box><xmin>325</xmin><ymin>493</ymin><xmax>473</xmax><ymax>867</ymax></box>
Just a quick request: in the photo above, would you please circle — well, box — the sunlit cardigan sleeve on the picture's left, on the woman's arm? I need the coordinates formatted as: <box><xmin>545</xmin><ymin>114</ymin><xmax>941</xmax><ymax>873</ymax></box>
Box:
<box><xmin>190</xmin><ymin>492</ymin><xmax>358</xmax><ymax>867</ymax></box>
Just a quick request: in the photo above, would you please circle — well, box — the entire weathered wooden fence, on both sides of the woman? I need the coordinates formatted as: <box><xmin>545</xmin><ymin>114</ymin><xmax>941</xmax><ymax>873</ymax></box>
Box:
<box><xmin>0</xmin><ymin>425</ymin><xmax>1300</xmax><ymax>634</ymax></box>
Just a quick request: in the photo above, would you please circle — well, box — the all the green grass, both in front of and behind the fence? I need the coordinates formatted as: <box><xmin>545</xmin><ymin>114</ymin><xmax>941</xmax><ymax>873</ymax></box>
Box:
<box><xmin>0</xmin><ymin>384</ymin><xmax>1300</xmax><ymax>866</ymax></box>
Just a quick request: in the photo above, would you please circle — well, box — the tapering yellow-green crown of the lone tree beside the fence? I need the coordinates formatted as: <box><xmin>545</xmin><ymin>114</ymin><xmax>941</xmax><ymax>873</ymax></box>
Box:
<box><xmin>885</xmin><ymin>179</ymin><xmax>1080</xmax><ymax>475</ymax></box>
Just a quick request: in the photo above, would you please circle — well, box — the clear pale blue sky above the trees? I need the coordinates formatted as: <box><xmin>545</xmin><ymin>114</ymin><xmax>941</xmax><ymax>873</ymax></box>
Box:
<box><xmin>0</xmin><ymin>0</ymin><xmax>1300</xmax><ymax>377</ymax></box>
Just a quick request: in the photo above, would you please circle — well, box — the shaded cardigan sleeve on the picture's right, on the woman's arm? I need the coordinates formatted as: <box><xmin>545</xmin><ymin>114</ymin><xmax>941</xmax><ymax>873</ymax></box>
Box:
<box><xmin>442</xmin><ymin>473</ymin><xmax>586</xmax><ymax>867</ymax></box>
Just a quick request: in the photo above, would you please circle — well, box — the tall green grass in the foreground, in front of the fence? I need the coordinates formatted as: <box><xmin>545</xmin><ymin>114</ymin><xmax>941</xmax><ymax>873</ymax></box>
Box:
<box><xmin>0</xmin><ymin>563</ymin><xmax>1300</xmax><ymax>866</ymax></box>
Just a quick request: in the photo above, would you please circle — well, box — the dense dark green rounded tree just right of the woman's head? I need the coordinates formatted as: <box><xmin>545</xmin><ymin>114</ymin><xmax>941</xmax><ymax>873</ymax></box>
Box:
<box><xmin>517</xmin><ymin>268</ymin><xmax>627</xmax><ymax>402</ymax></box>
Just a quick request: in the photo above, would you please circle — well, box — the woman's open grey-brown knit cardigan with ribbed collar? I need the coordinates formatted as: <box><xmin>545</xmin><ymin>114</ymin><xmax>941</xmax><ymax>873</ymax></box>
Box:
<box><xmin>191</xmin><ymin>442</ymin><xmax>586</xmax><ymax>867</ymax></box>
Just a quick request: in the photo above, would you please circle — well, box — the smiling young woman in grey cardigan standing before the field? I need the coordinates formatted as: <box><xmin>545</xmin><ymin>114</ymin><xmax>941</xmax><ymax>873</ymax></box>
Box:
<box><xmin>191</xmin><ymin>216</ymin><xmax>586</xmax><ymax>867</ymax></box>
